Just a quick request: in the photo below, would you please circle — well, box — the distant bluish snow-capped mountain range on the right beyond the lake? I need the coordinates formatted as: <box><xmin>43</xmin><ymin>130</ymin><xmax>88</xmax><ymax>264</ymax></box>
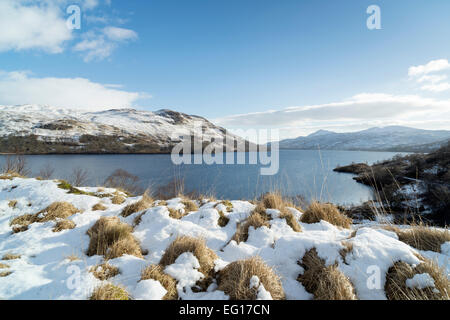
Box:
<box><xmin>280</xmin><ymin>126</ymin><xmax>450</xmax><ymax>152</ymax></box>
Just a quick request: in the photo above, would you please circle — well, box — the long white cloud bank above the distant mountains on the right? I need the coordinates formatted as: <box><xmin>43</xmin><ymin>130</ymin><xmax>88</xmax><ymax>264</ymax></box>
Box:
<box><xmin>214</xmin><ymin>93</ymin><xmax>450</xmax><ymax>138</ymax></box>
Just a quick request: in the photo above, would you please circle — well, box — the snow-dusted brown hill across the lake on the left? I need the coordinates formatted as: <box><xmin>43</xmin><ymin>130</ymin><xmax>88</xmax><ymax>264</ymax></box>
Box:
<box><xmin>0</xmin><ymin>105</ymin><xmax>250</xmax><ymax>154</ymax></box>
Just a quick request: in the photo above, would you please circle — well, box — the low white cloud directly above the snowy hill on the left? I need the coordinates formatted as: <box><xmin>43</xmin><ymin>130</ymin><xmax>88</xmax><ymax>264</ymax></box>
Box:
<box><xmin>0</xmin><ymin>71</ymin><xmax>147</xmax><ymax>110</ymax></box>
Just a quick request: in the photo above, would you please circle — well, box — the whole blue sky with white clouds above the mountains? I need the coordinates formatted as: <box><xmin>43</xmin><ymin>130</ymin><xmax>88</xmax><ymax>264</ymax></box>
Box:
<box><xmin>0</xmin><ymin>0</ymin><xmax>450</xmax><ymax>138</ymax></box>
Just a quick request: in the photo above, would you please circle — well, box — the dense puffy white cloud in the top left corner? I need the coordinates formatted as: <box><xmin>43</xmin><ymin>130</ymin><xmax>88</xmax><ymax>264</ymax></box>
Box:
<box><xmin>0</xmin><ymin>0</ymin><xmax>72</xmax><ymax>53</ymax></box>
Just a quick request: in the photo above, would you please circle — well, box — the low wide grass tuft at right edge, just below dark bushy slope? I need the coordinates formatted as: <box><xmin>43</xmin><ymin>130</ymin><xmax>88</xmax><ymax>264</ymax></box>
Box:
<box><xmin>386</xmin><ymin>225</ymin><xmax>450</xmax><ymax>252</ymax></box>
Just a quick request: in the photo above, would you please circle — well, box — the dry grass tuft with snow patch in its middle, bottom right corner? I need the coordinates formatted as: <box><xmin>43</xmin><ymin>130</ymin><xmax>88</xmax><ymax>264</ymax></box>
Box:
<box><xmin>385</xmin><ymin>257</ymin><xmax>450</xmax><ymax>300</ymax></box>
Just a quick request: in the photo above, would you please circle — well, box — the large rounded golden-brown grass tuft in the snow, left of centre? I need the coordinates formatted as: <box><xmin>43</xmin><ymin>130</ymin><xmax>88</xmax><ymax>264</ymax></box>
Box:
<box><xmin>87</xmin><ymin>217</ymin><xmax>142</xmax><ymax>259</ymax></box>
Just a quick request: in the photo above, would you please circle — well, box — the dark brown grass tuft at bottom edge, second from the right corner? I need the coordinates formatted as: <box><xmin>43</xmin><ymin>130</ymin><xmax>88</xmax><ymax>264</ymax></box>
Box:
<box><xmin>297</xmin><ymin>249</ymin><xmax>356</xmax><ymax>300</ymax></box>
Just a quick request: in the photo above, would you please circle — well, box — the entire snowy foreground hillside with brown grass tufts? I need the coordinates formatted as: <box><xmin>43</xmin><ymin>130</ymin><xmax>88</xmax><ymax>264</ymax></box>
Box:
<box><xmin>0</xmin><ymin>176</ymin><xmax>450</xmax><ymax>300</ymax></box>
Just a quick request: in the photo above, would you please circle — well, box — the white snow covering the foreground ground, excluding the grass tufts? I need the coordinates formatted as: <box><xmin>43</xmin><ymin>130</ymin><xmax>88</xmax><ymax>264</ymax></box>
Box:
<box><xmin>0</xmin><ymin>178</ymin><xmax>450</xmax><ymax>299</ymax></box>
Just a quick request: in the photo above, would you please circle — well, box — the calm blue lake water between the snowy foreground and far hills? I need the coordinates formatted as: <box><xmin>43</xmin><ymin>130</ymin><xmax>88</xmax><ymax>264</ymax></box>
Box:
<box><xmin>0</xmin><ymin>150</ymin><xmax>406</xmax><ymax>204</ymax></box>
